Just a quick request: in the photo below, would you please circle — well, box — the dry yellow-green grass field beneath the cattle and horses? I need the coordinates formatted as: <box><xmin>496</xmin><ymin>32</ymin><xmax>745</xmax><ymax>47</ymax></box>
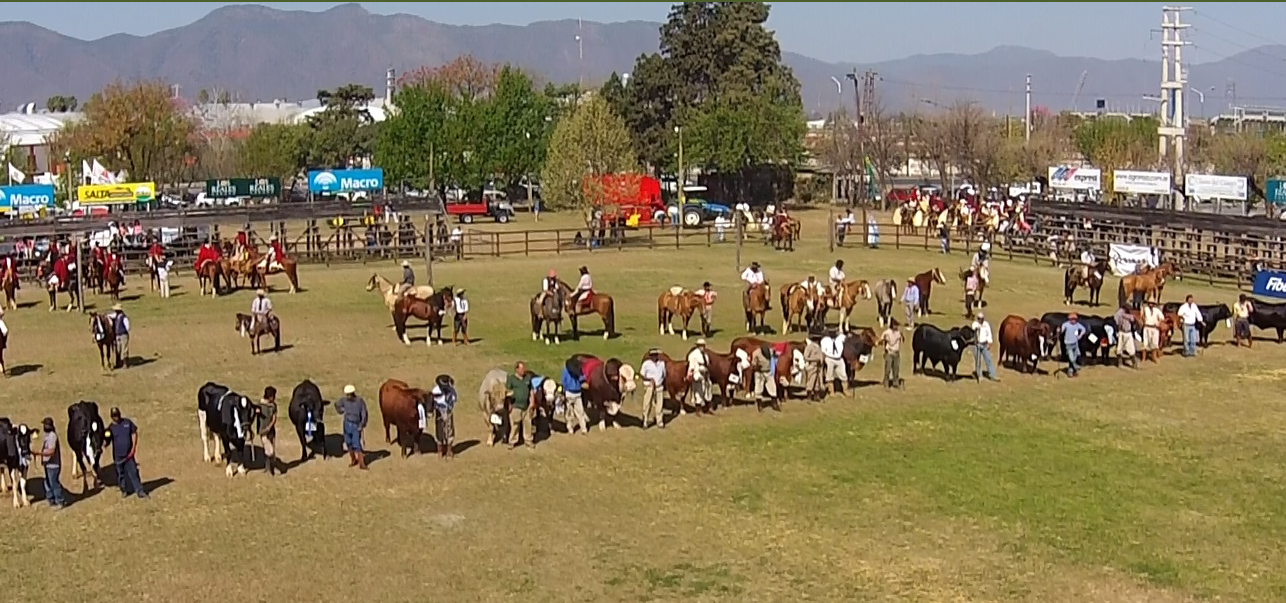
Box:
<box><xmin>0</xmin><ymin>208</ymin><xmax>1286</xmax><ymax>603</ymax></box>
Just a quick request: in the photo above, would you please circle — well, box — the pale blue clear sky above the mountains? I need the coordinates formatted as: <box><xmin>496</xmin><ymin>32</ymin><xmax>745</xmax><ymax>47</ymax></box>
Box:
<box><xmin>3</xmin><ymin>3</ymin><xmax>1286</xmax><ymax>63</ymax></box>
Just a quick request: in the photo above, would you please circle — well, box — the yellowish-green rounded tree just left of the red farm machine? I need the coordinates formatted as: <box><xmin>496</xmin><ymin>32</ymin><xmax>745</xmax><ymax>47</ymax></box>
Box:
<box><xmin>540</xmin><ymin>96</ymin><xmax>638</xmax><ymax>210</ymax></box>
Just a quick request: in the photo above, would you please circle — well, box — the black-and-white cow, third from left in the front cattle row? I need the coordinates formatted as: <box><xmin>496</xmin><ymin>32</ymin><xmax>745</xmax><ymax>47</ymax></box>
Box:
<box><xmin>197</xmin><ymin>382</ymin><xmax>257</xmax><ymax>477</ymax></box>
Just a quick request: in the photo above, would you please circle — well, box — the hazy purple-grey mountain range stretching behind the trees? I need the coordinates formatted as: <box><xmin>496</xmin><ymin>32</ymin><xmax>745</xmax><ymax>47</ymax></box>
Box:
<box><xmin>0</xmin><ymin>4</ymin><xmax>1286</xmax><ymax>116</ymax></box>
